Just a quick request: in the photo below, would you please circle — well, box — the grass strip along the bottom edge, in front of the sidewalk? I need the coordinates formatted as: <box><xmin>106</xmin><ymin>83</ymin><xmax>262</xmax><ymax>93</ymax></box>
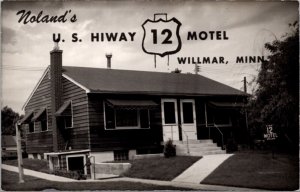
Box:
<box><xmin>1</xmin><ymin>170</ymin><xmax>190</xmax><ymax>191</ymax></box>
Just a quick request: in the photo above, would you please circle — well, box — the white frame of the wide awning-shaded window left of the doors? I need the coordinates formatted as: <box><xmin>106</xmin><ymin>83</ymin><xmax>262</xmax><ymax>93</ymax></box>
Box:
<box><xmin>103</xmin><ymin>101</ymin><xmax>151</xmax><ymax>131</ymax></box>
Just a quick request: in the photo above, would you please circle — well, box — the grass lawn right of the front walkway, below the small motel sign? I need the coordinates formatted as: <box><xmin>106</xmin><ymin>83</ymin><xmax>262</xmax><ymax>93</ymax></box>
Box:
<box><xmin>201</xmin><ymin>152</ymin><xmax>299</xmax><ymax>190</ymax></box>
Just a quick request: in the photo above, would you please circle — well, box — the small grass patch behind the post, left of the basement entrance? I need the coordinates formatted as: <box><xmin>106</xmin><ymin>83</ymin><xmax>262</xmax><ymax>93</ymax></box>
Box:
<box><xmin>2</xmin><ymin>159</ymin><xmax>49</xmax><ymax>173</ymax></box>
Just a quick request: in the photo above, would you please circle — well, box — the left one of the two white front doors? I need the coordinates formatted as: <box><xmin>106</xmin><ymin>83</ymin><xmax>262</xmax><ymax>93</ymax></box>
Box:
<box><xmin>161</xmin><ymin>99</ymin><xmax>179</xmax><ymax>141</ymax></box>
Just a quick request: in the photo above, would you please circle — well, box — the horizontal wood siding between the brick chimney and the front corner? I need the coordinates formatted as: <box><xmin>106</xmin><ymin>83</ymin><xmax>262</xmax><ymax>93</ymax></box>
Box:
<box><xmin>62</xmin><ymin>77</ymin><xmax>89</xmax><ymax>150</ymax></box>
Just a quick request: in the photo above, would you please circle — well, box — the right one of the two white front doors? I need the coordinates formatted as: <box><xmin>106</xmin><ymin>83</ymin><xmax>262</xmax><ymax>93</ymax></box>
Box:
<box><xmin>180</xmin><ymin>99</ymin><xmax>197</xmax><ymax>141</ymax></box>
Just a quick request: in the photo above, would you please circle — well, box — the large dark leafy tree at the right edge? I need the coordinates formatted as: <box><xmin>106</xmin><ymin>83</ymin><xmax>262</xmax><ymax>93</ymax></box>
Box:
<box><xmin>249</xmin><ymin>22</ymin><xmax>299</xmax><ymax>150</ymax></box>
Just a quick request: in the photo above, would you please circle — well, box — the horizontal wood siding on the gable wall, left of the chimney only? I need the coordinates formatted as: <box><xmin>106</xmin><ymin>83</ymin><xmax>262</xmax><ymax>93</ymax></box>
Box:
<box><xmin>23</xmin><ymin>70</ymin><xmax>53</xmax><ymax>153</ymax></box>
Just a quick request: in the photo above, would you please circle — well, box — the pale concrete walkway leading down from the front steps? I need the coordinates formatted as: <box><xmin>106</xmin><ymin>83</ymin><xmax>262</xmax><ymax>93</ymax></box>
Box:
<box><xmin>173</xmin><ymin>154</ymin><xmax>232</xmax><ymax>184</ymax></box>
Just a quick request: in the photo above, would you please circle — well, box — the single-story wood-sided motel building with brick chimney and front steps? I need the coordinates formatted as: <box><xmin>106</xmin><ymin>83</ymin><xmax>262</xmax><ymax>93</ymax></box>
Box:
<box><xmin>21</xmin><ymin>47</ymin><xmax>247</xmax><ymax>175</ymax></box>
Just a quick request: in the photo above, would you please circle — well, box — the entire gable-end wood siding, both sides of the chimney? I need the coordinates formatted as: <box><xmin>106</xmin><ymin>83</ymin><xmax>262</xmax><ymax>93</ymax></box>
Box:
<box><xmin>23</xmin><ymin>73</ymin><xmax>89</xmax><ymax>153</ymax></box>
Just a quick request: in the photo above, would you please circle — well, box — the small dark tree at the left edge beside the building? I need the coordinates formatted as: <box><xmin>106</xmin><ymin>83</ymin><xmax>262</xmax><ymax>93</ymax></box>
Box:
<box><xmin>1</xmin><ymin>106</ymin><xmax>22</xmax><ymax>135</ymax></box>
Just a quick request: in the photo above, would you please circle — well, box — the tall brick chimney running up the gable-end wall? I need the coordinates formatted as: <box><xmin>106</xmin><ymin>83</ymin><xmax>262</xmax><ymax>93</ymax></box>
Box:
<box><xmin>50</xmin><ymin>45</ymin><xmax>63</xmax><ymax>152</ymax></box>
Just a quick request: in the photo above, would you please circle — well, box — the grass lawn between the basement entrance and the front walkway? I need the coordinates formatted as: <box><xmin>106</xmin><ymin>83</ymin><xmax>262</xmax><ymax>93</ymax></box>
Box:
<box><xmin>124</xmin><ymin>156</ymin><xmax>201</xmax><ymax>181</ymax></box>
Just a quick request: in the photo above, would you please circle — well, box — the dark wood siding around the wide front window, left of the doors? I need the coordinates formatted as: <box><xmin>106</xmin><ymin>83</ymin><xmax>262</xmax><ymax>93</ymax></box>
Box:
<box><xmin>88</xmin><ymin>95</ymin><xmax>162</xmax><ymax>151</ymax></box>
